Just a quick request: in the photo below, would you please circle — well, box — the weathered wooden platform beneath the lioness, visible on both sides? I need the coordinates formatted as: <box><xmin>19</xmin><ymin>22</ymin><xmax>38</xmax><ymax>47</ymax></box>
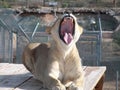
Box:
<box><xmin>0</xmin><ymin>63</ymin><xmax>106</xmax><ymax>90</ymax></box>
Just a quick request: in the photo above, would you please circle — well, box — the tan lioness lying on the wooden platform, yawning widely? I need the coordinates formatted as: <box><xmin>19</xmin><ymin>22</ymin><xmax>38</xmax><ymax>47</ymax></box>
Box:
<box><xmin>23</xmin><ymin>14</ymin><xmax>84</xmax><ymax>90</ymax></box>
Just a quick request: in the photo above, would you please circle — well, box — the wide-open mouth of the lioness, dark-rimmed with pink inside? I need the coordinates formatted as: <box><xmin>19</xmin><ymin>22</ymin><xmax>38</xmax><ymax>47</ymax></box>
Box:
<box><xmin>59</xmin><ymin>15</ymin><xmax>75</xmax><ymax>44</ymax></box>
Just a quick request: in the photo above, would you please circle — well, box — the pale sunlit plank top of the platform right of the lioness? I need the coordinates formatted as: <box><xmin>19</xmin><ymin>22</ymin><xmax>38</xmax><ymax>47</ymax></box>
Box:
<box><xmin>84</xmin><ymin>67</ymin><xmax>106</xmax><ymax>90</ymax></box>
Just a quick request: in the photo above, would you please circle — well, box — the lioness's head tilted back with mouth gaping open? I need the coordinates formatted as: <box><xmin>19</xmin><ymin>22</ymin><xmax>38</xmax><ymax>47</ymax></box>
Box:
<box><xmin>45</xmin><ymin>14</ymin><xmax>83</xmax><ymax>47</ymax></box>
